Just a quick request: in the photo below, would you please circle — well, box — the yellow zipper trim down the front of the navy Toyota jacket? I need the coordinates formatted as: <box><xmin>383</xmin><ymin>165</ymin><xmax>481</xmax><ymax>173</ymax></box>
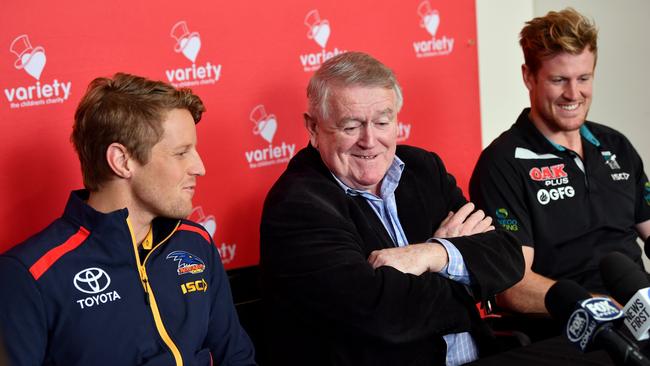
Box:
<box><xmin>126</xmin><ymin>218</ymin><xmax>183</xmax><ymax>366</ymax></box>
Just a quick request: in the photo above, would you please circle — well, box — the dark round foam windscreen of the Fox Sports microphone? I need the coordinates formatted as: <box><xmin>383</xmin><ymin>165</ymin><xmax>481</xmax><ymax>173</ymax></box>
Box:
<box><xmin>544</xmin><ymin>280</ymin><xmax>591</xmax><ymax>323</ymax></box>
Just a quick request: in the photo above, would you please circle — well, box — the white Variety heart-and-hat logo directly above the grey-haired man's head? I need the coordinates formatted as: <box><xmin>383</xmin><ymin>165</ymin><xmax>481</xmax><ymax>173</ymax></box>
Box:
<box><xmin>300</xmin><ymin>9</ymin><xmax>346</xmax><ymax>72</ymax></box>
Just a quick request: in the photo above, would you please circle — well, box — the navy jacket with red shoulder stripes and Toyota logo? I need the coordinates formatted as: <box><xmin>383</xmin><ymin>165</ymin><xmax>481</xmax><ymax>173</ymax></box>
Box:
<box><xmin>0</xmin><ymin>192</ymin><xmax>254</xmax><ymax>366</ymax></box>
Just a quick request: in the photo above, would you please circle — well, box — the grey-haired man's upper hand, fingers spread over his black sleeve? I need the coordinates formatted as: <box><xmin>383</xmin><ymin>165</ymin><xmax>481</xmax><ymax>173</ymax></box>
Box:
<box><xmin>433</xmin><ymin>202</ymin><xmax>494</xmax><ymax>238</ymax></box>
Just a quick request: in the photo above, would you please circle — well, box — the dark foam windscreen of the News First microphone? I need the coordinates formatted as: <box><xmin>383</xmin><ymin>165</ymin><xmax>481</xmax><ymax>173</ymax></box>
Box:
<box><xmin>600</xmin><ymin>252</ymin><xmax>650</xmax><ymax>304</ymax></box>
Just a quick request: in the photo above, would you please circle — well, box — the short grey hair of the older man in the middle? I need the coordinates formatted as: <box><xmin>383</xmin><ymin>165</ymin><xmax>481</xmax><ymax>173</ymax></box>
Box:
<box><xmin>307</xmin><ymin>52</ymin><xmax>404</xmax><ymax>119</ymax></box>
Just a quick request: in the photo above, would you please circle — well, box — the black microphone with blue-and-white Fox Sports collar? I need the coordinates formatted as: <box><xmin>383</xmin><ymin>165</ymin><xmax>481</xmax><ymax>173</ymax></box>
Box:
<box><xmin>544</xmin><ymin>280</ymin><xmax>650</xmax><ymax>366</ymax></box>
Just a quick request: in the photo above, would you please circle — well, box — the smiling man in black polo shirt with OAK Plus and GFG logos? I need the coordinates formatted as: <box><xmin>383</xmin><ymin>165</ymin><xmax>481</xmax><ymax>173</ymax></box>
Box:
<box><xmin>470</xmin><ymin>8</ymin><xmax>650</xmax><ymax>314</ymax></box>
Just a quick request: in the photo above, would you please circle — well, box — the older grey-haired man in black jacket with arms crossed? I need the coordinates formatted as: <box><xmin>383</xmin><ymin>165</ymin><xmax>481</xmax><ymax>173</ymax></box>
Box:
<box><xmin>261</xmin><ymin>52</ymin><xmax>523</xmax><ymax>366</ymax></box>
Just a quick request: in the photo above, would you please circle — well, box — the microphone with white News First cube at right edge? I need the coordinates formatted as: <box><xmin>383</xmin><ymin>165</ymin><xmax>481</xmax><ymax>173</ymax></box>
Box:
<box><xmin>600</xmin><ymin>252</ymin><xmax>650</xmax><ymax>341</ymax></box>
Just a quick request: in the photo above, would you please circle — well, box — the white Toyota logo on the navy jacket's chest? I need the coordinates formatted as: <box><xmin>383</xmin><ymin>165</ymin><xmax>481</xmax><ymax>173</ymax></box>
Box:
<box><xmin>72</xmin><ymin>267</ymin><xmax>121</xmax><ymax>309</ymax></box>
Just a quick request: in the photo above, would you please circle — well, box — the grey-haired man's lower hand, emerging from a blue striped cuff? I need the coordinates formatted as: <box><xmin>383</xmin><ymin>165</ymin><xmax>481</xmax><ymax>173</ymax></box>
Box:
<box><xmin>368</xmin><ymin>243</ymin><xmax>449</xmax><ymax>275</ymax></box>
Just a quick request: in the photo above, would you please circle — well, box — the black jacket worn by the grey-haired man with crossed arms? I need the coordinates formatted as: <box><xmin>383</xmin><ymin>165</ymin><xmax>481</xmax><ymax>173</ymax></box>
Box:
<box><xmin>261</xmin><ymin>146</ymin><xmax>524</xmax><ymax>365</ymax></box>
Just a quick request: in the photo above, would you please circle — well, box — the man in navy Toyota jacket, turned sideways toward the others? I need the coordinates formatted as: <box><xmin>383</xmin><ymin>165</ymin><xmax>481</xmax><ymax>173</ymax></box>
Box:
<box><xmin>0</xmin><ymin>73</ymin><xmax>255</xmax><ymax>366</ymax></box>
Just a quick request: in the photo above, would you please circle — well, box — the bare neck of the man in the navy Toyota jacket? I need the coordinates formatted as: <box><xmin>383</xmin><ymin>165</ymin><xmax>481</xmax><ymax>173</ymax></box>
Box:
<box><xmin>87</xmin><ymin>185</ymin><xmax>154</xmax><ymax>243</ymax></box>
